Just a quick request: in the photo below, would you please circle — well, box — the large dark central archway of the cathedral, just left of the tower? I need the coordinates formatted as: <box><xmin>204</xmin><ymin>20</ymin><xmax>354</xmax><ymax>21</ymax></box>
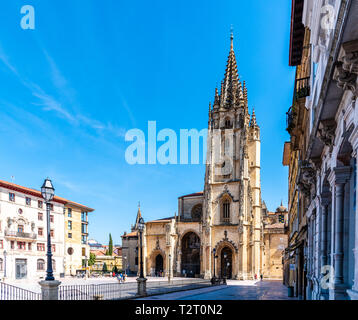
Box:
<box><xmin>181</xmin><ymin>232</ymin><xmax>200</xmax><ymax>278</ymax></box>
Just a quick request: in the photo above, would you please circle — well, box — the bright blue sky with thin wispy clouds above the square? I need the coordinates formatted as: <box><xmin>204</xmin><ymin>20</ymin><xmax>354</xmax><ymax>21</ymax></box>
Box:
<box><xmin>0</xmin><ymin>0</ymin><xmax>294</xmax><ymax>243</ymax></box>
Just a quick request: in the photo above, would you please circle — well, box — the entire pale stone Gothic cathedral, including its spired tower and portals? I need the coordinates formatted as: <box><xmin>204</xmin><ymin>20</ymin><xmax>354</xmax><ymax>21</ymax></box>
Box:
<box><xmin>122</xmin><ymin>35</ymin><xmax>287</xmax><ymax>280</ymax></box>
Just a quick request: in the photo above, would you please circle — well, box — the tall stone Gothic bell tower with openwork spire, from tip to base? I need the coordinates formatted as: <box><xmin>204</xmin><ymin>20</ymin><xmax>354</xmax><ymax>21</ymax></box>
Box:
<box><xmin>202</xmin><ymin>34</ymin><xmax>262</xmax><ymax>279</ymax></box>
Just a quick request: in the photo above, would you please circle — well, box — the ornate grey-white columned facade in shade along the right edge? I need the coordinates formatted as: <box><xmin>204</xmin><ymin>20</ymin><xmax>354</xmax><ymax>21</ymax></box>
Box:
<box><xmin>290</xmin><ymin>0</ymin><xmax>358</xmax><ymax>300</ymax></box>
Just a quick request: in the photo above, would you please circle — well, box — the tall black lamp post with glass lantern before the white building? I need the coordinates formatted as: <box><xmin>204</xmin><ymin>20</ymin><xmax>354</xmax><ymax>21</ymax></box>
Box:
<box><xmin>41</xmin><ymin>178</ymin><xmax>55</xmax><ymax>281</ymax></box>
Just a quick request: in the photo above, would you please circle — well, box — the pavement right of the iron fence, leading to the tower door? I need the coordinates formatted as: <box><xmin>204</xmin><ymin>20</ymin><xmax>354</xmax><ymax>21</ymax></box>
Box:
<box><xmin>139</xmin><ymin>280</ymin><xmax>295</xmax><ymax>300</ymax></box>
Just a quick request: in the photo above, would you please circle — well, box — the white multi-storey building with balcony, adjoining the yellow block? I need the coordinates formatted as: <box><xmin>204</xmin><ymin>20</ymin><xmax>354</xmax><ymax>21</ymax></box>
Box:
<box><xmin>0</xmin><ymin>181</ymin><xmax>66</xmax><ymax>280</ymax></box>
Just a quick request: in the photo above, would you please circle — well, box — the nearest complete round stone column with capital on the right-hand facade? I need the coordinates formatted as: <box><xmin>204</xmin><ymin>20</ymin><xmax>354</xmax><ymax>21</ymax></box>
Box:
<box><xmin>330</xmin><ymin>167</ymin><xmax>351</xmax><ymax>300</ymax></box>
